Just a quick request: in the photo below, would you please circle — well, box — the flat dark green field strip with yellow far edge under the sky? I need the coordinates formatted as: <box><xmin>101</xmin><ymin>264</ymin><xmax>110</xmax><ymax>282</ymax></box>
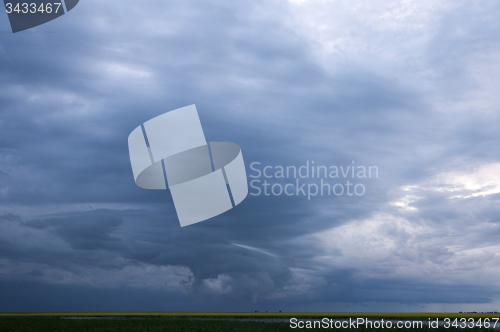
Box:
<box><xmin>0</xmin><ymin>312</ymin><xmax>500</xmax><ymax>332</ymax></box>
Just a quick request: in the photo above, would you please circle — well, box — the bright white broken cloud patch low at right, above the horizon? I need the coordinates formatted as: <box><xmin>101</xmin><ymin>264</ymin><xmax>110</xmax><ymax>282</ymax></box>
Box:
<box><xmin>306</xmin><ymin>214</ymin><xmax>500</xmax><ymax>287</ymax></box>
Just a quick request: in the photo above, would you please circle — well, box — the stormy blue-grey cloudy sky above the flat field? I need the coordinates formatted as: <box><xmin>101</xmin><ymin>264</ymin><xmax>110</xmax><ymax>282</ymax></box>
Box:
<box><xmin>0</xmin><ymin>0</ymin><xmax>500</xmax><ymax>311</ymax></box>
